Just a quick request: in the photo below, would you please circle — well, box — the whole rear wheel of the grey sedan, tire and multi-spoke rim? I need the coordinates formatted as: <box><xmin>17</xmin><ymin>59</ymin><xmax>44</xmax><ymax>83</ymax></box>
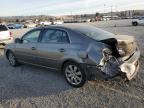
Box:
<box><xmin>63</xmin><ymin>62</ymin><xmax>86</xmax><ymax>88</ymax></box>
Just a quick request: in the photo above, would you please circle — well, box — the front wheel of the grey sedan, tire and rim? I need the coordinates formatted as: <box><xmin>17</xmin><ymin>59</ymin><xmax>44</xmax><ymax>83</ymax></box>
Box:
<box><xmin>7</xmin><ymin>51</ymin><xmax>19</xmax><ymax>67</ymax></box>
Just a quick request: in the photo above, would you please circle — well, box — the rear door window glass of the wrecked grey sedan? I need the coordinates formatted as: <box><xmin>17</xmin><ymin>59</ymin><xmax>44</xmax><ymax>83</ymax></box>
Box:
<box><xmin>41</xmin><ymin>29</ymin><xmax>69</xmax><ymax>43</ymax></box>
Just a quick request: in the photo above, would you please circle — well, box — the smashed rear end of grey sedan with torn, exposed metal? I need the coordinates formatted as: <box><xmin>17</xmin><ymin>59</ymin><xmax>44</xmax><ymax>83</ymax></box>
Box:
<box><xmin>89</xmin><ymin>36</ymin><xmax>140</xmax><ymax>80</ymax></box>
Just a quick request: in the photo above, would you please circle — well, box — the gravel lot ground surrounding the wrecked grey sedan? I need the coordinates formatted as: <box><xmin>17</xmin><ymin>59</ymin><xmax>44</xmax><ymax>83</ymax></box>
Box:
<box><xmin>0</xmin><ymin>20</ymin><xmax>144</xmax><ymax>108</ymax></box>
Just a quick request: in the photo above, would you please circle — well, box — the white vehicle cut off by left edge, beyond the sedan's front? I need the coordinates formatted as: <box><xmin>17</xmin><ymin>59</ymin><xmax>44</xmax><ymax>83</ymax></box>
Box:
<box><xmin>0</xmin><ymin>24</ymin><xmax>13</xmax><ymax>45</ymax></box>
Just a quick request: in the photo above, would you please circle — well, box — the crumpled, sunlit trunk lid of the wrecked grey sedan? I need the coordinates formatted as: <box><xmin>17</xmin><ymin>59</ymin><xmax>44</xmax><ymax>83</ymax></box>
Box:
<box><xmin>101</xmin><ymin>35</ymin><xmax>137</xmax><ymax>57</ymax></box>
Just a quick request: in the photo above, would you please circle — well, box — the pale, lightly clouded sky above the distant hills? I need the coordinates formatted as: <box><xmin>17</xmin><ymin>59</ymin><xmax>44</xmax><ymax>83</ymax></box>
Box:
<box><xmin>0</xmin><ymin>0</ymin><xmax>144</xmax><ymax>16</ymax></box>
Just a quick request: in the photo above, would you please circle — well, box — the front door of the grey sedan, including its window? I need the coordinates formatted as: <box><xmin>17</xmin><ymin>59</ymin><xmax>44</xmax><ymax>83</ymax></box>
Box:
<box><xmin>15</xmin><ymin>29</ymin><xmax>41</xmax><ymax>64</ymax></box>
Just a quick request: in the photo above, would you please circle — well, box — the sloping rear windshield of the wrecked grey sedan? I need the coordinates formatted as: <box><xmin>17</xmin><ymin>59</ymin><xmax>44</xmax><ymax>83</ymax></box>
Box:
<box><xmin>75</xmin><ymin>26</ymin><xmax>114</xmax><ymax>40</ymax></box>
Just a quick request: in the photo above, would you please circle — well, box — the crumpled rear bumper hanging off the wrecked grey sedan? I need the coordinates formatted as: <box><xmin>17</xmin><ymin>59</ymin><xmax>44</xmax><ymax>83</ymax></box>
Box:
<box><xmin>87</xmin><ymin>49</ymin><xmax>140</xmax><ymax>80</ymax></box>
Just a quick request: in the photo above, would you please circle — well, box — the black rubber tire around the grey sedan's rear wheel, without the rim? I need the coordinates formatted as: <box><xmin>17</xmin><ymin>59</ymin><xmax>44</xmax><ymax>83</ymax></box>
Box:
<box><xmin>63</xmin><ymin>62</ymin><xmax>86</xmax><ymax>88</ymax></box>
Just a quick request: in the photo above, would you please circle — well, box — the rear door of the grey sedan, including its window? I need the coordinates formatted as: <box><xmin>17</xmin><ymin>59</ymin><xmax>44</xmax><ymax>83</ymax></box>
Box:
<box><xmin>37</xmin><ymin>29</ymin><xmax>70</xmax><ymax>68</ymax></box>
